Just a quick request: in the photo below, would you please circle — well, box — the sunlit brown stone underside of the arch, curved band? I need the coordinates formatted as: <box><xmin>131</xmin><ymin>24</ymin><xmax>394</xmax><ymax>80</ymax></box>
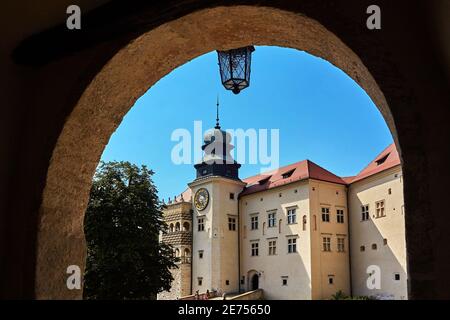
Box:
<box><xmin>35</xmin><ymin>6</ymin><xmax>400</xmax><ymax>298</ymax></box>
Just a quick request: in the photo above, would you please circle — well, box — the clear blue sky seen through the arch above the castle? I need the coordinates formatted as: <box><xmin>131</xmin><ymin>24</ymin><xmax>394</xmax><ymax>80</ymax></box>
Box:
<box><xmin>102</xmin><ymin>47</ymin><xmax>392</xmax><ymax>199</ymax></box>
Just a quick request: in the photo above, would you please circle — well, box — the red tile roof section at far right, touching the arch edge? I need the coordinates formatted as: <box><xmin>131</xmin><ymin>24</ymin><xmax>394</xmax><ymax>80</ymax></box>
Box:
<box><xmin>348</xmin><ymin>143</ymin><xmax>400</xmax><ymax>183</ymax></box>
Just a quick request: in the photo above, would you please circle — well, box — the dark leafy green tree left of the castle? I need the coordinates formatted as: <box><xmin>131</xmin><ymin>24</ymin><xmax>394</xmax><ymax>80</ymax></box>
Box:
<box><xmin>84</xmin><ymin>162</ymin><xmax>176</xmax><ymax>299</ymax></box>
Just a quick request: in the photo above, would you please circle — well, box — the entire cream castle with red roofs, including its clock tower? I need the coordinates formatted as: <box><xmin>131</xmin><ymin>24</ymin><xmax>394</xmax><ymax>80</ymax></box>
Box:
<box><xmin>158</xmin><ymin>114</ymin><xmax>407</xmax><ymax>299</ymax></box>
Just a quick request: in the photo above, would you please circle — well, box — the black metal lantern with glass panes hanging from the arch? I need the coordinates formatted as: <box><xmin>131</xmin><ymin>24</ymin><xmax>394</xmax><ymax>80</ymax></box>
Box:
<box><xmin>217</xmin><ymin>46</ymin><xmax>255</xmax><ymax>94</ymax></box>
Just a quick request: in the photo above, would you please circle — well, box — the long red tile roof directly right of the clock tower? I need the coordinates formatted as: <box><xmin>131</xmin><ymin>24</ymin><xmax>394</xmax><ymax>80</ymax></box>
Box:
<box><xmin>241</xmin><ymin>160</ymin><xmax>346</xmax><ymax>195</ymax></box>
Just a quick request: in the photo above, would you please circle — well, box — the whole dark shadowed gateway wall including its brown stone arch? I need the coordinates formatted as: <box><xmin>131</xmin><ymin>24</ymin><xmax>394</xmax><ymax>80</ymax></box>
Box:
<box><xmin>0</xmin><ymin>0</ymin><xmax>440</xmax><ymax>299</ymax></box>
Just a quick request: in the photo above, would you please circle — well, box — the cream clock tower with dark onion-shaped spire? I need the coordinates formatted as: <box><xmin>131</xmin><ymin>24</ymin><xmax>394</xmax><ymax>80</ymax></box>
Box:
<box><xmin>189</xmin><ymin>103</ymin><xmax>245</xmax><ymax>294</ymax></box>
